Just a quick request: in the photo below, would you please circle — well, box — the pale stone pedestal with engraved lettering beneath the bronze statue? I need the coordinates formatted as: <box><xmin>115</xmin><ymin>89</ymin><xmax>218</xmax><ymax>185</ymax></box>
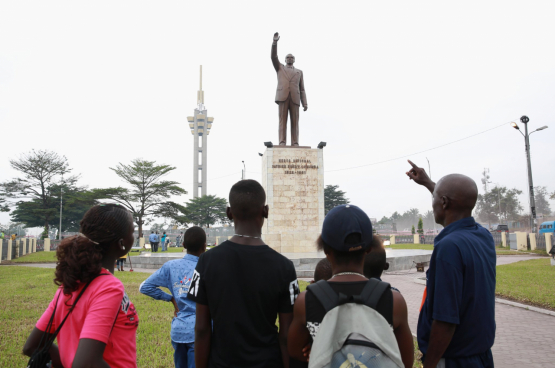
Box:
<box><xmin>262</xmin><ymin>146</ymin><xmax>324</xmax><ymax>253</ymax></box>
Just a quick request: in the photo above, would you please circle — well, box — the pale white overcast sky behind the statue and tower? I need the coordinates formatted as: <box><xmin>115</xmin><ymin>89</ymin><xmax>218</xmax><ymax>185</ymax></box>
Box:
<box><xmin>0</xmin><ymin>1</ymin><xmax>555</xmax><ymax>230</ymax></box>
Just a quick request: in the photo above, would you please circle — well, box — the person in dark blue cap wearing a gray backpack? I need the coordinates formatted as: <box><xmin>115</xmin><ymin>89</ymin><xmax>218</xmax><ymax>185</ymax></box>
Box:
<box><xmin>287</xmin><ymin>205</ymin><xmax>414</xmax><ymax>368</ymax></box>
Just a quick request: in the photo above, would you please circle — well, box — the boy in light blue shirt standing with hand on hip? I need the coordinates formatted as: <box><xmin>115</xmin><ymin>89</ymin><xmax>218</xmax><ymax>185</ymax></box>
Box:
<box><xmin>139</xmin><ymin>226</ymin><xmax>206</xmax><ymax>368</ymax></box>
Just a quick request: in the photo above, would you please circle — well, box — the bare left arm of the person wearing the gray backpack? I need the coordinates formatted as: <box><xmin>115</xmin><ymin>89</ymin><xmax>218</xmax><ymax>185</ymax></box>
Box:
<box><xmin>287</xmin><ymin>291</ymin><xmax>310</xmax><ymax>362</ymax></box>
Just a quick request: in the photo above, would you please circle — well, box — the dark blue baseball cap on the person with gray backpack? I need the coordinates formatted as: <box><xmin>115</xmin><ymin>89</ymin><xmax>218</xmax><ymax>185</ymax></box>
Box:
<box><xmin>322</xmin><ymin>204</ymin><xmax>372</xmax><ymax>252</ymax></box>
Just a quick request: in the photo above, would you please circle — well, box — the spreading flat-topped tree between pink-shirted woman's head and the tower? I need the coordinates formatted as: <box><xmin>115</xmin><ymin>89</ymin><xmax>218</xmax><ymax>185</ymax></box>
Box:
<box><xmin>99</xmin><ymin>159</ymin><xmax>187</xmax><ymax>234</ymax></box>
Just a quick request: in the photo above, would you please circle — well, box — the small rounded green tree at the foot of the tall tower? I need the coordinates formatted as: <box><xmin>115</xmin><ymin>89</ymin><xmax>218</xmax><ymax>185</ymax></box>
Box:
<box><xmin>186</xmin><ymin>195</ymin><xmax>229</xmax><ymax>227</ymax></box>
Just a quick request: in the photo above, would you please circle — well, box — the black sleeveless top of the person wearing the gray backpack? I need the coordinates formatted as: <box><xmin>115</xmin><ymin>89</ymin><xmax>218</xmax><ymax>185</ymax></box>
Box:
<box><xmin>305</xmin><ymin>281</ymin><xmax>393</xmax><ymax>340</ymax></box>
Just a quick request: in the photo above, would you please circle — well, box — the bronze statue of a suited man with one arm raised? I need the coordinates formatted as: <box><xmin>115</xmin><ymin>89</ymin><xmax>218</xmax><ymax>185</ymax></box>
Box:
<box><xmin>272</xmin><ymin>32</ymin><xmax>308</xmax><ymax>146</ymax></box>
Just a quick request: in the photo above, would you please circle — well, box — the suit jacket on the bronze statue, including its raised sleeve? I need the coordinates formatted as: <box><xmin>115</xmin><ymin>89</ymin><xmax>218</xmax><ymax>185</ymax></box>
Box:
<box><xmin>272</xmin><ymin>43</ymin><xmax>307</xmax><ymax>106</ymax></box>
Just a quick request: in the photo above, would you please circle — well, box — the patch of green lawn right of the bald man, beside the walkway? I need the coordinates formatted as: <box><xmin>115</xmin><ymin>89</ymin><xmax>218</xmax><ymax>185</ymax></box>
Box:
<box><xmin>495</xmin><ymin>258</ymin><xmax>555</xmax><ymax>310</ymax></box>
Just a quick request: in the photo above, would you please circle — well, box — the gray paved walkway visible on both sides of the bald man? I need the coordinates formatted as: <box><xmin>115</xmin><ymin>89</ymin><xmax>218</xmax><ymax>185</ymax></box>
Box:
<box><xmin>382</xmin><ymin>256</ymin><xmax>555</xmax><ymax>368</ymax></box>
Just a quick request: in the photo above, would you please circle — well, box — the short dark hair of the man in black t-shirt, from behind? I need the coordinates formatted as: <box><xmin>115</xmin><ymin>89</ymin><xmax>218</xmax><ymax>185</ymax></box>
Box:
<box><xmin>229</xmin><ymin>179</ymin><xmax>266</xmax><ymax>220</ymax></box>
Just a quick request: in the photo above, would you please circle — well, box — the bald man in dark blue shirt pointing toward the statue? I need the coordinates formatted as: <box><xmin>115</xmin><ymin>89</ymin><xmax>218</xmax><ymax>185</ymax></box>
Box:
<box><xmin>407</xmin><ymin>161</ymin><xmax>496</xmax><ymax>368</ymax></box>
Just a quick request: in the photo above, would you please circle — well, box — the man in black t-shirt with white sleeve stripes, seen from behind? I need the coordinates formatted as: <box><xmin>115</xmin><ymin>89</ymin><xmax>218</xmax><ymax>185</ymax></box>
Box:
<box><xmin>188</xmin><ymin>180</ymin><xmax>299</xmax><ymax>368</ymax></box>
